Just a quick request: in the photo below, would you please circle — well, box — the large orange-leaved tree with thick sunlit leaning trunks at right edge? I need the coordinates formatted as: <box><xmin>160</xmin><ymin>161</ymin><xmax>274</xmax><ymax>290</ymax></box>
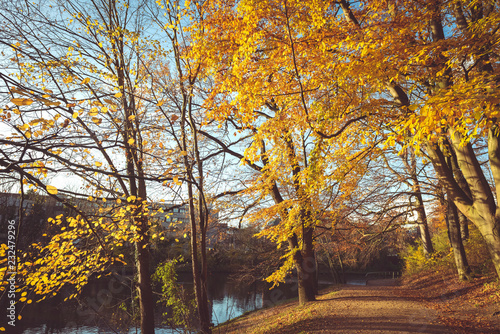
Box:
<box><xmin>336</xmin><ymin>1</ymin><xmax>500</xmax><ymax>275</ymax></box>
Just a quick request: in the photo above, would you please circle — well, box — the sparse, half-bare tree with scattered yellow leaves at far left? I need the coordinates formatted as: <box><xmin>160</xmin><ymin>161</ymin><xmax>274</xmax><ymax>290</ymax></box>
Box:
<box><xmin>1</xmin><ymin>1</ymin><xmax>186</xmax><ymax>333</ymax></box>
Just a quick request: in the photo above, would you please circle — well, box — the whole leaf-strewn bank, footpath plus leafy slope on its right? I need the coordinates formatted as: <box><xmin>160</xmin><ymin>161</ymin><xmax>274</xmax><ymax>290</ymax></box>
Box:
<box><xmin>214</xmin><ymin>273</ymin><xmax>500</xmax><ymax>334</ymax></box>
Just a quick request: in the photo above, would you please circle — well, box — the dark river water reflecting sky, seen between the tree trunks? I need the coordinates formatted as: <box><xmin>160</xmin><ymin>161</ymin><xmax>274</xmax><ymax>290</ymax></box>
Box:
<box><xmin>18</xmin><ymin>273</ymin><xmax>324</xmax><ymax>334</ymax></box>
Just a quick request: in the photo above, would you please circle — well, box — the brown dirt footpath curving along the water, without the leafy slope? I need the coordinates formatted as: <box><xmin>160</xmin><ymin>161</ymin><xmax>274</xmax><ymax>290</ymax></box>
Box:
<box><xmin>214</xmin><ymin>280</ymin><xmax>500</xmax><ymax>334</ymax></box>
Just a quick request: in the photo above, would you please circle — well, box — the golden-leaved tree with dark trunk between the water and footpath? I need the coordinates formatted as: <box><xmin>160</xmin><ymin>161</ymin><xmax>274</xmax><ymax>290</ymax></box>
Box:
<box><xmin>192</xmin><ymin>1</ymin><xmax>375</xmax><ymax>303</ymax></box>
